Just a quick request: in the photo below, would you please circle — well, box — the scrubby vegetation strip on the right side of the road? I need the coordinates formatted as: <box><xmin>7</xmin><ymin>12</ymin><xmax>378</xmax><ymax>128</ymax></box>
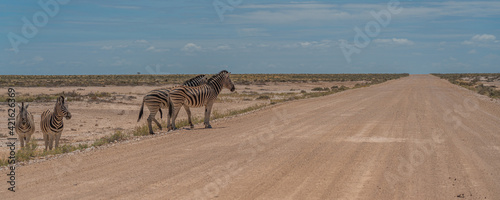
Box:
<box><xmin>432</xmin><ymin>73</ymin><xmax>500</xmax><ymax>98</ymax></box>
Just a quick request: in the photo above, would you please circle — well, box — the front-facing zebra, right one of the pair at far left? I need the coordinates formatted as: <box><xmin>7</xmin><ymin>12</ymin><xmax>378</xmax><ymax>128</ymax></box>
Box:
<box><xmin>40</xmin><ymin>96</ymin><xmax>71</xmax><ymax>151</ymax></box>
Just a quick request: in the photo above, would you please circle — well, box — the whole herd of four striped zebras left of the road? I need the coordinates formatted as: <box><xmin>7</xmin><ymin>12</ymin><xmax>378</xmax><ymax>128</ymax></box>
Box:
<box><xmin>15</xmin><ymin>70</ymin><xmax>235</xmax><ymax>150</ymax></box>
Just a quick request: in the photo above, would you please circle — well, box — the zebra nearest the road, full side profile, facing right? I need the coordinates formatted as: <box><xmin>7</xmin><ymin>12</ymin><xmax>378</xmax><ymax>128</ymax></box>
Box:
<box><xmin>169</xmin><ymin>70</ymin><xmax>235</xmax><ymax>129</ymax></box>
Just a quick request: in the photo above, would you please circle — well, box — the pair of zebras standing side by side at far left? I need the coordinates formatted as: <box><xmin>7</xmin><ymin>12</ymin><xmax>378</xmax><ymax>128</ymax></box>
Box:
<box><xmin>15</xmin><ymin>96</ymin><xmax>71</xmax><ymax>150</ymax></box>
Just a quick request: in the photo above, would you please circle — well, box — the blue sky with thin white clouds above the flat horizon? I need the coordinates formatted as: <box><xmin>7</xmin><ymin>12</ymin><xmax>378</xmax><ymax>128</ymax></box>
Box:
<box><xmin>0</xmin><ymin>0</ymin><xmax>500</xmax><ymax>75</ymax></box>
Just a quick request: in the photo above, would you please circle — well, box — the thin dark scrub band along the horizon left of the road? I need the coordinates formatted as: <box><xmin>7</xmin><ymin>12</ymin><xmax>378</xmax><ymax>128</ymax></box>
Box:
<box><xmin>0</xmin><ymin>74</ymin><xmax>408</xmax><ymax>87</ymax></box>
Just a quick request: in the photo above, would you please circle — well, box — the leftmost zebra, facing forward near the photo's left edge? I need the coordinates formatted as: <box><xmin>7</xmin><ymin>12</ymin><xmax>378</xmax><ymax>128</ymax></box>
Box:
<box><xmin>15</xmin><ymin>102</ymin><xmax>35</xmax><ymax>148</ymax></box>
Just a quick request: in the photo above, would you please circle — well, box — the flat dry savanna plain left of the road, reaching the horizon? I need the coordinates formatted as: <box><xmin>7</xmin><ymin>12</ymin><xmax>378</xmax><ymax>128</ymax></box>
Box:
<box><xmin>0</xmin><ymin>74</ymin><xmax>382</xmax><ymax>158</ymax></box>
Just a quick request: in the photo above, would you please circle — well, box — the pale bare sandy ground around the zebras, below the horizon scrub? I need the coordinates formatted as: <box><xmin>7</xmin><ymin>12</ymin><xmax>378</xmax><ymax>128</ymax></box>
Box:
<box><xmin>0</xmin><ymin>81</ymin><xmax>358</xmax><ymax>158</ymax></box>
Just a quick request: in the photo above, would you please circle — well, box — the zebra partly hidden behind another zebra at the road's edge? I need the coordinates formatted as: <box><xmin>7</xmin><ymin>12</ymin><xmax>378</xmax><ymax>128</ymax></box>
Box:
<box><xmin>137</xmin><ymin>75</ymin><xmax>207</xmax><ymax>134</ymax></box>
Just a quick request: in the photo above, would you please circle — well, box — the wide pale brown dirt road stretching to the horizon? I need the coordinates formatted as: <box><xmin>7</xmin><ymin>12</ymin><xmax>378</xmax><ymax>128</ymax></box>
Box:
<box><xmin>0</xmin><ymin>75</ymin><xmax>500</xmax><ymax>199</ymax></box>
